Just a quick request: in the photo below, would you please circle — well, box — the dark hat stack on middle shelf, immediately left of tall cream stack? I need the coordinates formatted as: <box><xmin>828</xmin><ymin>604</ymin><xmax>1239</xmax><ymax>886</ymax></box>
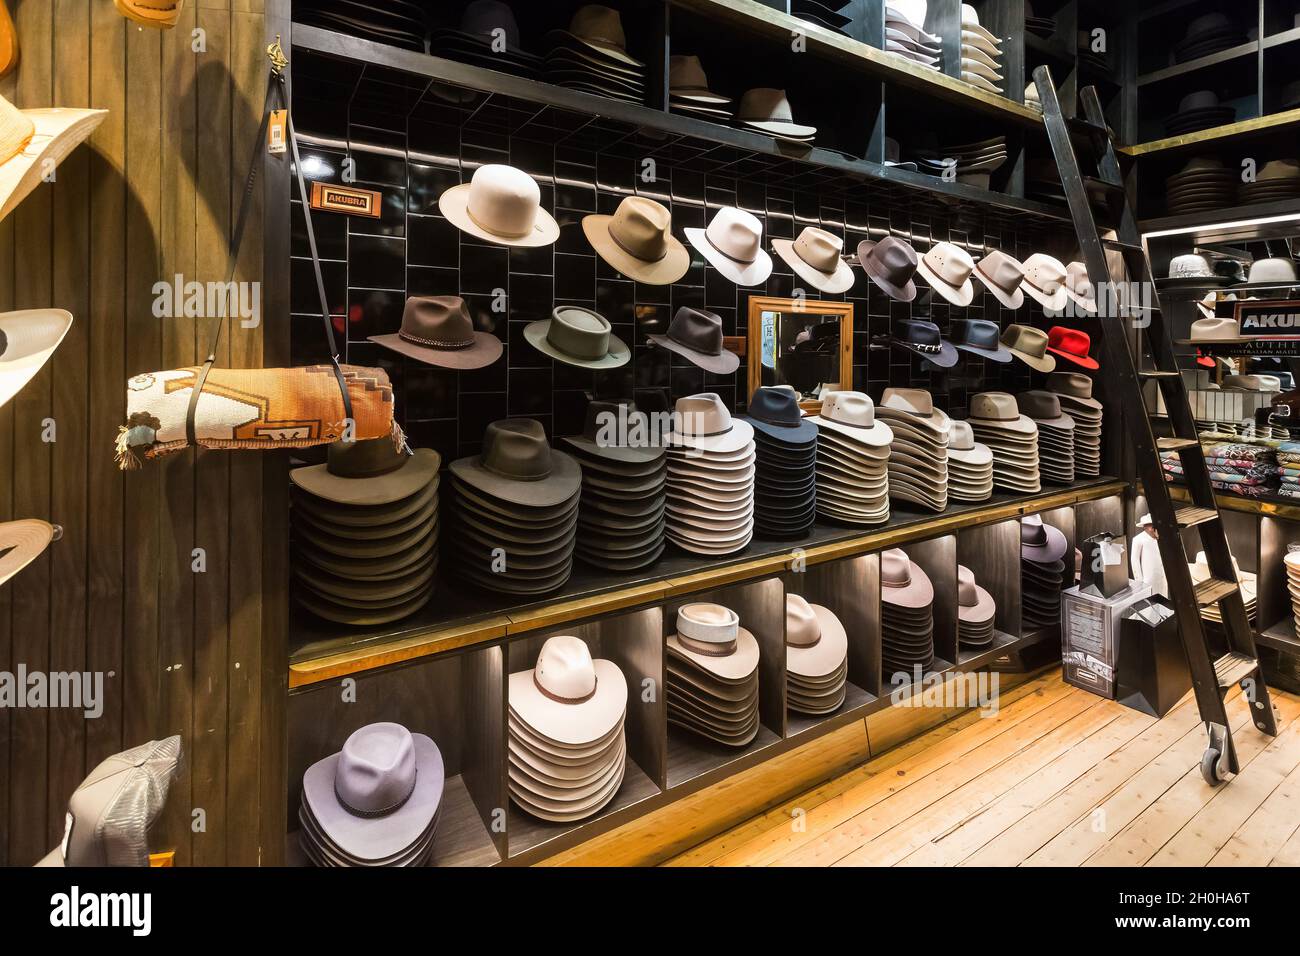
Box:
<box><xmin>562</xmin><ymin>402</ymin><xmax>668</xmax><ymax>571</ymax></box>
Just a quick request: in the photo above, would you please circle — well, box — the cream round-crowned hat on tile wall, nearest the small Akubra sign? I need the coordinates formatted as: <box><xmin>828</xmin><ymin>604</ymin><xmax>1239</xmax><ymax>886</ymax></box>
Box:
<box><xmin>438</xmin><ymin>163</ymin><xmax>560</xmax><ymax>247</ymax></box>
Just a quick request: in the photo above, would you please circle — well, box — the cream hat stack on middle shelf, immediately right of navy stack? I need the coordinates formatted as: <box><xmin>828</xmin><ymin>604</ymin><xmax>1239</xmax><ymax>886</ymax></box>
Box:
<box><xmin>811</xmin><ymin>392</ymin><xmax>893</xmax><ymax>524</ymax></box>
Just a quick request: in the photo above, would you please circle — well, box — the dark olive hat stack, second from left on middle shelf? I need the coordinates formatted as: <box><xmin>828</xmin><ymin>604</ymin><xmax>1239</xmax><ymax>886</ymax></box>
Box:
<box><xmin>446</xmin><ymin>419</ymin><xmax>582</xmax><ymax>594</ymax></box>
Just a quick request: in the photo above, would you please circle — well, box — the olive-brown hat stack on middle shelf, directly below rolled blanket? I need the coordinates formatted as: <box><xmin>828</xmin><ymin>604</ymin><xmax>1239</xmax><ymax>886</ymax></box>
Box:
<box><xmin>289</xmin><ymin>438</ymin><xmax>442</xmax><ymax>626</ymax></box>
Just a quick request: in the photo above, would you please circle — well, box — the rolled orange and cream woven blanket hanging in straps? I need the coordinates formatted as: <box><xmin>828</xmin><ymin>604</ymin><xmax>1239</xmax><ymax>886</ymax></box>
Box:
<box><xmin>116</xmin><ymin>365</ymin><xmax>406</xmax><ymax>471</ymax></box>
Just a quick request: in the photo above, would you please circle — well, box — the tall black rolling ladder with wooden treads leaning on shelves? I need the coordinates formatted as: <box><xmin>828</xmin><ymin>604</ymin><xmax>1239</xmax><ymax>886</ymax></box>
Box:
<box><xmin>1034</xmin><ymin>66</ymin><xmax>1278</xmax><ymax>784</ymax></box>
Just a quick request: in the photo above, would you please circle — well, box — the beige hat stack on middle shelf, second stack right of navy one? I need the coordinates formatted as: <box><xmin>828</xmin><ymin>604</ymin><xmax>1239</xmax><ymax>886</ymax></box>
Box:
<box><xmin>876</xmin><ymin>389</ymin><xmax>952</xmax><ymax>511</ymax></box>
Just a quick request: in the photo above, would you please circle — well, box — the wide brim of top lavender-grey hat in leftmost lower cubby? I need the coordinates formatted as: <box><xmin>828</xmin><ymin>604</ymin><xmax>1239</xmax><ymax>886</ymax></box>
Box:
<box><xmin>303</xmin><ymin>734</ymin><xmax>445</xmax><ymax>860</ymax></box>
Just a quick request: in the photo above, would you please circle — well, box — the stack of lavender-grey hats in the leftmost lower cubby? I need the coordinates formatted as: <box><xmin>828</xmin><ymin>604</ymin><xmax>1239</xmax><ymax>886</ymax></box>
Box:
<box><xmin>298</xmin><ymin>723</ymin><xmax>446</xmax><ymax>868</ymax></box>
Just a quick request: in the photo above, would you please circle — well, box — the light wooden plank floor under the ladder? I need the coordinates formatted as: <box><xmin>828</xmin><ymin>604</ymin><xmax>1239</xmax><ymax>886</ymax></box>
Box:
<box><xmin>668</xmin><ymin>672</ymin><xmax>1300</xmax><ymax>866</ymax></box>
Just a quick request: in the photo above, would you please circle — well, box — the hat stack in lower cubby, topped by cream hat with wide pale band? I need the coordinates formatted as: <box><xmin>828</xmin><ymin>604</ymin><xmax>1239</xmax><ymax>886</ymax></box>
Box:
<box><xmin>667</xmin><ymin>604</ymin><xmax>758</xmax><ymax>747</ymax></box>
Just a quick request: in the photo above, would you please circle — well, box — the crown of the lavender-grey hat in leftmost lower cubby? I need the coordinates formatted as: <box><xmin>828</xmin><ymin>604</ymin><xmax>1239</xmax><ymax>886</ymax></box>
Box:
<box><xmin>334</xmin><ymin>723</ymin><xmax>416</xmax><ymax>817</ymax></box>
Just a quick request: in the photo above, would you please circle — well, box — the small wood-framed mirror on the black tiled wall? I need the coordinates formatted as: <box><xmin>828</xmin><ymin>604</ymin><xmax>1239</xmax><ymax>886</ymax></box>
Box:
<box><xmin>745</xmin><ymin>295</ymin><xmax>853</xmax><ymax>412</ymax></box>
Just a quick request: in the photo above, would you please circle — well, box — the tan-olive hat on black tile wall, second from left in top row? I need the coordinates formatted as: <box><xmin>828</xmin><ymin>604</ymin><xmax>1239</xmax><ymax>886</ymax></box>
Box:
<box><xmin>582</xmin><ymin>196</ymin><xmax>690</xmax><ymax>285</ymax></box>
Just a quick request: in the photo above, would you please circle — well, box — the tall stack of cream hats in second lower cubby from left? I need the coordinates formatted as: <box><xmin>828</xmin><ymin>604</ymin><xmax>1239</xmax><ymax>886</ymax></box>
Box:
<box><xmin>506</xmin><ymin>635</ymin><xmax>628</xmax><ymax>823</ymax></box>
